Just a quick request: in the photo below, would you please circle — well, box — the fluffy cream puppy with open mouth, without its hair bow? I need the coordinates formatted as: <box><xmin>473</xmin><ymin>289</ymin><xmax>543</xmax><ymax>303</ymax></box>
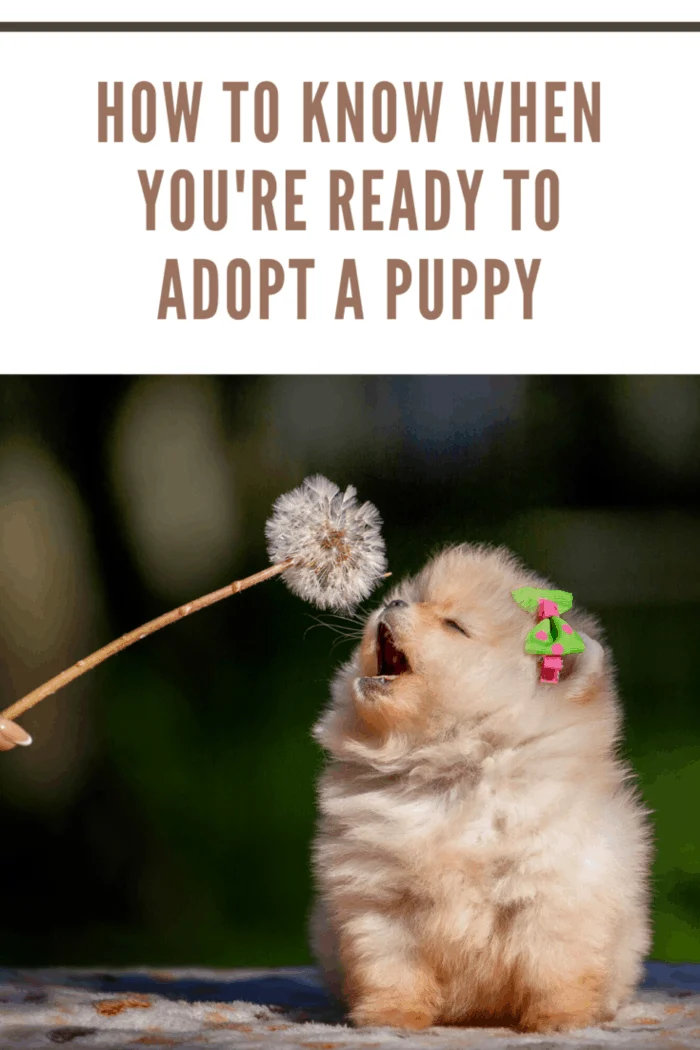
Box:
<box><xmin>312</xmin><ymin>546</ymin><xmax>650</xmax><ymax>1032</ymax></box>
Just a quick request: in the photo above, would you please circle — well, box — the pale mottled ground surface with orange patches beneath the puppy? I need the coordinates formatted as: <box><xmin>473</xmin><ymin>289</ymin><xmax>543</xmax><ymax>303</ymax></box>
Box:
<box><xmin>0</xmin><ymin>963</ymin><xmax>700</xmax><ymax>1050</ymax></box>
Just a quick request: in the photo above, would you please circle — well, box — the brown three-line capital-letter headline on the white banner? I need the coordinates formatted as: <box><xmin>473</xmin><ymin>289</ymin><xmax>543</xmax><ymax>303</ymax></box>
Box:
<box><xmin>98</xmin><ymin>80</ymin><xmax>600</xmax><ymax>321</ymax></box>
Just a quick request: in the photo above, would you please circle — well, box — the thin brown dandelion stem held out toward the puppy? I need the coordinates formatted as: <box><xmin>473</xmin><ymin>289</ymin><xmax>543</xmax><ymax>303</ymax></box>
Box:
<box><xmin>0</xmin><ymin>558</ymin><xmax>294</xmax><ymax>718</ymax></box>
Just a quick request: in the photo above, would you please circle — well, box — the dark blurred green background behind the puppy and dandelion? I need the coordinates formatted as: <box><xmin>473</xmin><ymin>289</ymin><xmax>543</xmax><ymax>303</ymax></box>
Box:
<box><xmin>0</xmin><ymin>376</ymin><xmax>700</xmax><ymax>966</ymax></box>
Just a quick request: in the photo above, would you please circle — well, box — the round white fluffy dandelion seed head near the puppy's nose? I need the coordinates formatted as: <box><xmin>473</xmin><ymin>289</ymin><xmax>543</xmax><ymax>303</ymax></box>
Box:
<box><xmin>264</xmin><ymin>475</ymin><xmax>386</xmax><ymax>609</ymax></box>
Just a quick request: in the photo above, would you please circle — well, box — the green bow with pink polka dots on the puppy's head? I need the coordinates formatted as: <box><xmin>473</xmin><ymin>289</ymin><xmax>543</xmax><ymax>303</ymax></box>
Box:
<box><xmin>512</xmin><ymin>587</ymin><xmax>586</xmax><ymax>685</ymax></box>
